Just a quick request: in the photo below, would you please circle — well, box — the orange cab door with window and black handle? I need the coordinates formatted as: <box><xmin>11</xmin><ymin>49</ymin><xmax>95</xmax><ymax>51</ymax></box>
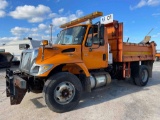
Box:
<box><xmin>82</xmin><ymin>25</ymin><xmax>108</xmax><ymax>69</ymax></box>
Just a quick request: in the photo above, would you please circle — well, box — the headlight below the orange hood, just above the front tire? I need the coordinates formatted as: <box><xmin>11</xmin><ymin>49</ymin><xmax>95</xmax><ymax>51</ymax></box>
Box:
<box><xmin>30</xmin><ymin>63</ymin><xmax>53</xmax><ymax>76</ymax></box>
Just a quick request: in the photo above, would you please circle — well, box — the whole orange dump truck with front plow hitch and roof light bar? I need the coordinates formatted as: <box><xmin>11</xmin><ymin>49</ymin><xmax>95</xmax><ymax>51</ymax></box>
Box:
<box><xmin>6</xmin><ymin>12</ymin><xmax>155</xmax><ymax>112</ymax></box>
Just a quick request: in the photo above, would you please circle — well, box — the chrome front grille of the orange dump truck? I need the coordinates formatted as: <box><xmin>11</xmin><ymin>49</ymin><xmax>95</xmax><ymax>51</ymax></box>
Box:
<box><xmin>20</xmin><ymin>52</ymin><xmax>32</xmax><ymax>73</ymax></box>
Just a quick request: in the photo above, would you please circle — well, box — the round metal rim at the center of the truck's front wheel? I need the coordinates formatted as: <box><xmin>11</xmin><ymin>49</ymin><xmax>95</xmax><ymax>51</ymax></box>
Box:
<box><xmin>54</xmin><ymin>81</ymin><xmax>75</xmax><ymax>105</ymax></box>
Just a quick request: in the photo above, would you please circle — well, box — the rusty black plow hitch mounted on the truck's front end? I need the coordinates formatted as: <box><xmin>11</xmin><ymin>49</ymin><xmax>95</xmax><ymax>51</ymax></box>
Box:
<box><xmin>6</xmin><ymin>69</ymin><xmax>27</xmax><ymax>105</ymax></box>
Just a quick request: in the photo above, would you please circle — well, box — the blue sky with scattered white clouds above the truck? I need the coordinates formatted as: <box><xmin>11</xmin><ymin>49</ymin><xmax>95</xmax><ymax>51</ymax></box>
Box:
<box><xmin>0</xmin><ymin>0</ymin><xmax>160</xmax><ymax>49</ymax></box>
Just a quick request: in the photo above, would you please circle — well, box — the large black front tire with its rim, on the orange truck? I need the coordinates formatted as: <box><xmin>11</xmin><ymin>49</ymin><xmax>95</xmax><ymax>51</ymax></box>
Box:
<box><xmin>43</xmin><ymin>72</ymin><xmax>82</xmax><ymax>113</ymax></box>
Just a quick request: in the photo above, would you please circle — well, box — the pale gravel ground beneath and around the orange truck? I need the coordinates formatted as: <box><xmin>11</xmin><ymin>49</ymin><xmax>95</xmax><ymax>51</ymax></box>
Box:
<box><xmin>0</xmin><ymin>62</ymin><xmax>160</xmax><ymax>120</ymax></box>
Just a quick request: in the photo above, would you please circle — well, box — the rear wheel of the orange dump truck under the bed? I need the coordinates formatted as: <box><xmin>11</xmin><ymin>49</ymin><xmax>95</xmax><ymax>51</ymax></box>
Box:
<box><xmin>134</xmin><ymin>65</ymin><xmax>149</xmax><ymax>86</ymax></box>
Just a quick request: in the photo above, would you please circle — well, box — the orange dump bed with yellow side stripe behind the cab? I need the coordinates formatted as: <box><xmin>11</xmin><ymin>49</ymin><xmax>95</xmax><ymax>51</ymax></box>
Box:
<box><xmin>105</xmin><ymin>21</ymin><xmax>155</xmax><ymax>62</ymax></box>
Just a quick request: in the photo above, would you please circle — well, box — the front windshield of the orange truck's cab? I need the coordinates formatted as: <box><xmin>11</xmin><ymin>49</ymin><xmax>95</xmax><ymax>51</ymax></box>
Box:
<box><xmin>55</xmin><ymin>26</ymin><xmax>86</xmax><ymax>44</ymax></box>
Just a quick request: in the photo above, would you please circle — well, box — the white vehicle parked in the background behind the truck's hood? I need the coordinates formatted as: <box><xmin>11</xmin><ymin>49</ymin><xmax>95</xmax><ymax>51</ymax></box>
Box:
<box><xmin>0</xmin><ymin>38</ymin><xmax>41</xmax><ymax>62</ymax></box>
